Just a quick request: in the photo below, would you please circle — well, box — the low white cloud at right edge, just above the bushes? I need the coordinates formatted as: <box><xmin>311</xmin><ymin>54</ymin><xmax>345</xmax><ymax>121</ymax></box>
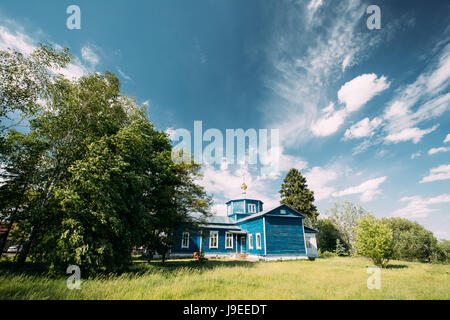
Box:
<box><xmin>392</xmin><ymin>194</ymin><xmax>450</xmax><ymax>218</ymax></box>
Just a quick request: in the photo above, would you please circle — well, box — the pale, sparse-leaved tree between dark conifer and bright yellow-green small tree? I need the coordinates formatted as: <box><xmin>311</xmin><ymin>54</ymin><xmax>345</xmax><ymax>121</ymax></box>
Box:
<box><xmin>327</xmin><ymin>201</ymin><xmax>368</xmax><ymax>253</ymax></box>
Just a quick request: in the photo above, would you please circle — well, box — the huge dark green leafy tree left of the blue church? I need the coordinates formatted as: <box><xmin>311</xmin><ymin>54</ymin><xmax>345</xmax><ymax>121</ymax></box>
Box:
<box><xmin>2</xmin><ymin>45</ymin><xmax>210</xmax><ymax>271</ymax></box>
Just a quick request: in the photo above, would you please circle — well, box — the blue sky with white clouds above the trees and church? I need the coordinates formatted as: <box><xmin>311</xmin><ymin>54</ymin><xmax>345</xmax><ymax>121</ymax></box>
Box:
<box><xmin>0</xmin><ymin>0</ymin><xmax>450</xmax><ymax>239</ymax></box>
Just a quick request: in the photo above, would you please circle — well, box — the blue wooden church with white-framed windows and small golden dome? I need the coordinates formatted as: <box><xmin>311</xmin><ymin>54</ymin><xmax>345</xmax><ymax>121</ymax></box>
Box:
<box><xmin>170</xmin><ymin>183</ymin><xmax>317</xmax><ymax>260</ymax></box>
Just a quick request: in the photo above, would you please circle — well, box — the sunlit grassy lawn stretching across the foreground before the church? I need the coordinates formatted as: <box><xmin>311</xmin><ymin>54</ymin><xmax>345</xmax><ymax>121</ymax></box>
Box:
<box><xmin>0</xmin><ymin>258</ymin><xmax>450</xmax><ymax>300</ymax></box>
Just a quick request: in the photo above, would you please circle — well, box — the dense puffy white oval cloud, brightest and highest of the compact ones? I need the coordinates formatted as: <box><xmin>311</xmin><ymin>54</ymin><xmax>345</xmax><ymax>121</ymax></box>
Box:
<box><xmin>338</xmin><ymin>73</ymin><xmax>390</xmax><ymax>112</ymax></box>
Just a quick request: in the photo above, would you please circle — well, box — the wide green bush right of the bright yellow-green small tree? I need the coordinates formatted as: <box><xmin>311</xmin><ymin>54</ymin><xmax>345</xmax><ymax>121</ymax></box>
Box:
<box><xmin>383</xmin><ymin>218</ymin><xmax>438</xmax><ymax>262</ymax></box>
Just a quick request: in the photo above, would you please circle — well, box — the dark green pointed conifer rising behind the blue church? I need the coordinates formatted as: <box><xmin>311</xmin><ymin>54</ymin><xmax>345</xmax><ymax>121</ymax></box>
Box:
<box><xmin>280</xmin><ymin>168</ymin><xmax>319</xmax><ymax>226</ymax></box>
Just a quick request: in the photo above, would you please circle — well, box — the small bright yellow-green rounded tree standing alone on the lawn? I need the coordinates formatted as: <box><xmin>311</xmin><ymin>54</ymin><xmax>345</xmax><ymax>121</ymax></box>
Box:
<box><xmin>355</xmin><ymin>215</ymin><xmax>393</xmax><ymax>268</ymax></box>
